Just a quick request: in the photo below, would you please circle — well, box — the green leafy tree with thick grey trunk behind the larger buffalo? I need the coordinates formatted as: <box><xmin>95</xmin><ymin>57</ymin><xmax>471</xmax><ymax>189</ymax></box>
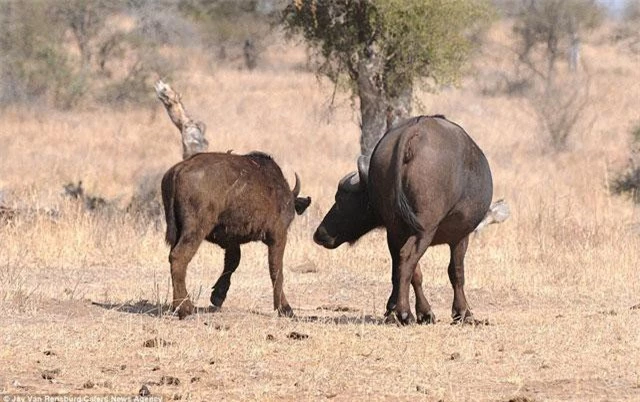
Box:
<box><xmin>283</xmin><ymin>0</ymin><xmax>493</xmax><ymax>154</ymax></box>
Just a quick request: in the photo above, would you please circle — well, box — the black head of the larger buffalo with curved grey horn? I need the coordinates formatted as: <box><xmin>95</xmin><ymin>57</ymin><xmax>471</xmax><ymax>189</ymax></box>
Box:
<box><xmin>313</xmin><ymin>156</ymin><xmax>377</xmax><ymax>249</ymax></box>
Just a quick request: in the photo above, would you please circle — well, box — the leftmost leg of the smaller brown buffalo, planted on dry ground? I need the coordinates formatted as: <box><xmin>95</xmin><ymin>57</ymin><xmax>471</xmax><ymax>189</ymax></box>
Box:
<box><xmin>169</xmin><ymin>234</ymin><xmax>202</xmax><ymax>319</ymax></box>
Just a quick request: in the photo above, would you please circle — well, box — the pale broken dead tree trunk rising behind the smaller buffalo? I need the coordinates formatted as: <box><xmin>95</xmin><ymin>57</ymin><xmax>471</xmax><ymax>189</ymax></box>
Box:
<box><xmin>155</xmin><ymin>80</ymin><xmax>209</xmax><ymax>159</ymax></box>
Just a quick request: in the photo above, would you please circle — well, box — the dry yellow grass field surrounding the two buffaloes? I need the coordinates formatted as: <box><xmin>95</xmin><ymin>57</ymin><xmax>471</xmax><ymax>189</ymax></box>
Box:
<box><xmin>0</xmin><ymin>23</ymin><xmax>640</xmax><ymax>401</ymax></box>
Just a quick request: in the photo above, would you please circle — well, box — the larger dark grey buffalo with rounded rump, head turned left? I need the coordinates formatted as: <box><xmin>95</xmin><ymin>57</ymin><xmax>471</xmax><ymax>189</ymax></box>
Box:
<box><xmin>314</xmin><ymin>115</ymin><xmax>493</xmax><ymax>324</ymax></box>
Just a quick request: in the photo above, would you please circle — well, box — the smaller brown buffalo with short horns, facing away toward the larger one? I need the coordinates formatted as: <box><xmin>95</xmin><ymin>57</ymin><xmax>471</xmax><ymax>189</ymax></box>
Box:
<box><xmin>162</xmin><ymin>152</ymin><xmax>311</xmax><ymax>319</ymax></box>
